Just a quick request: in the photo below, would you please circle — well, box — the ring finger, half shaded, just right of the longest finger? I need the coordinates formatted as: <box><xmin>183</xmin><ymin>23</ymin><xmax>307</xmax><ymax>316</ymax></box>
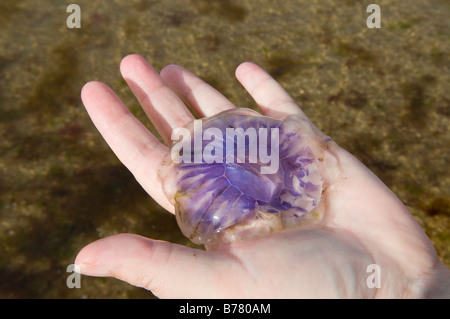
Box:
<box><xmin>161</xmin><ymin>65</ymin><xmax>235</xmax><ymax>117</ymax></box>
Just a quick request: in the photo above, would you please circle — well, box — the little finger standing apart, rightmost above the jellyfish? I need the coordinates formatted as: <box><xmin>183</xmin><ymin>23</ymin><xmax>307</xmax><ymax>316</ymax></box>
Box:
<box><xmin>236</xmin><ymin>62</ymin><xmax>306</xmax><ymax>118</ymax></box>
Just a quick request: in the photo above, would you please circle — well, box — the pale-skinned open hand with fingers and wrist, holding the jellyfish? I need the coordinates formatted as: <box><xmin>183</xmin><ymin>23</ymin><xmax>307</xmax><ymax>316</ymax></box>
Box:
<box><xmin>75</xmin><ymin>55</ymin><xmax>450</xmax><ymax>298</ymax></box>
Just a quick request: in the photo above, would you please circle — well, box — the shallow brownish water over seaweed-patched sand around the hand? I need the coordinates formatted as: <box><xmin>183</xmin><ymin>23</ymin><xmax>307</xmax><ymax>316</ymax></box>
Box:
<box><xmin>0</xmin><ymin>0</ymin><xmax>450</xmax><ymax>298</ymax></box>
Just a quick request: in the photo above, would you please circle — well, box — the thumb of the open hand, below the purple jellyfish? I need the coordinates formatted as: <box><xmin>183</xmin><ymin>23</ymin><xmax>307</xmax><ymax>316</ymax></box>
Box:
<box><xmin>75</xmin><ymin>234</ymin><xmax>232</xmax><ymax>298</ymax></box>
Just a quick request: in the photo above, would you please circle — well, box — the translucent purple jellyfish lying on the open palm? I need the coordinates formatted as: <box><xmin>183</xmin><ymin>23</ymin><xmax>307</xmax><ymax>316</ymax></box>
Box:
<box><xmin>159</xmin><ymin>108</ymin><xmax>322</xmax><ymax>244</ymax></box>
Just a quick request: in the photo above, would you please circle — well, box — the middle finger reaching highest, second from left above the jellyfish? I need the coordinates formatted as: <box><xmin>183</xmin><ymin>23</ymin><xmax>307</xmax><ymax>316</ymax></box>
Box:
<box><xmin>120</xmin><ymin>54</ymin><xmax>194</xmax><ymax>143</ymax></box>
